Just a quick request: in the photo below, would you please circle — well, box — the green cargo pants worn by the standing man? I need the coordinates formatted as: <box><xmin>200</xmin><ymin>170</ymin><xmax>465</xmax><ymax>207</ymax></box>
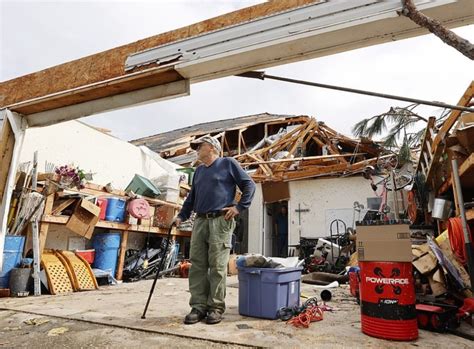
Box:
<box><xmin>189</xmin><ymin>216</ymin><xmax>235</xmax><ymax>313</ymax></box>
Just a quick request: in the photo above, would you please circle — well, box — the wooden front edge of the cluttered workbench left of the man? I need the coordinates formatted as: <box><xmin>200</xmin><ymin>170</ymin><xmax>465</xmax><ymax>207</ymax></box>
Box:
<box><xmin>41</xmin><ymin>215</ymin><xmax>191</xmax><ymax>237</ymax></box>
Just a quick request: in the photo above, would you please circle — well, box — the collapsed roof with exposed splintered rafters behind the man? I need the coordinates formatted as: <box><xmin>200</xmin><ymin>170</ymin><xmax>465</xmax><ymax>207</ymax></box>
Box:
<box><xmin>132</xmin><ymin>113</ymin><xmax>383</xmax><ymax>182</ymax></box>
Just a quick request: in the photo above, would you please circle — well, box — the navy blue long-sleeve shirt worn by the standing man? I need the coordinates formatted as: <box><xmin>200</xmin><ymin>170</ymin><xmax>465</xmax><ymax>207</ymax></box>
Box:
<box><xmin>178</xmin><ymin>158</ymin><xmax>255</xmax><ymax>221</ymax></box>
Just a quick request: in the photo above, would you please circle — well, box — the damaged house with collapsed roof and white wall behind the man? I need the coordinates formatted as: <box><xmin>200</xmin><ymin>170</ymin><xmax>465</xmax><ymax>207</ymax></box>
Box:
<box><xmin>132</xmin><ymin>113</ymin><xmax>390</xmax><ymax>255</ymax></box>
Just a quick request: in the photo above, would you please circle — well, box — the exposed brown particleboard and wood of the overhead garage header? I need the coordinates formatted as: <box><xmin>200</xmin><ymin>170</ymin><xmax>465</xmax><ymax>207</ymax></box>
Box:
<box><xmin>0</xmin><ymin>0</ymin><xmax>319</xmax><ymax>111</ymax></box>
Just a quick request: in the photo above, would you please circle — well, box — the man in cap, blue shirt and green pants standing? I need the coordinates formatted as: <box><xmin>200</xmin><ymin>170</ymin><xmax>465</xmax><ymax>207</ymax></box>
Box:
<box><xmin>176</xmin><ymin>136</ymin><xmax>255</xmax><ymax>324</ymax></box>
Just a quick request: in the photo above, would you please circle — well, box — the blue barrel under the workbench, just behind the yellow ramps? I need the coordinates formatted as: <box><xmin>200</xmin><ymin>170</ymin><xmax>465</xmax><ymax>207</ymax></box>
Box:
<box><xmin>92</xmin><ymin>233</ymin><xmax>121</xmax><ymax>276</ymax></box>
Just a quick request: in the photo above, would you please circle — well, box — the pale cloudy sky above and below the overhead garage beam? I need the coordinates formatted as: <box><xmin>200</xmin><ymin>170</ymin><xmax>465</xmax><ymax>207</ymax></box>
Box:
<box><xmin>0</xmin><ymin>0</ymin><xmax>474</xmax><ymax>140</ymax></box>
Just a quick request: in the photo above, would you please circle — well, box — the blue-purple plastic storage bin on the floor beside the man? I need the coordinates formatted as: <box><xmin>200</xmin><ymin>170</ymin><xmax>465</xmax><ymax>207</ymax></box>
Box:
<box><xmin>238</xmin><ymin>267</ymin><xmax>303</xmax><ymax>319</ymax></box>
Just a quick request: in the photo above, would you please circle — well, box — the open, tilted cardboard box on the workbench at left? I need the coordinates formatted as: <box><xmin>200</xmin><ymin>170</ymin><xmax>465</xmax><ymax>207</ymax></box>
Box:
<box><xmin>66</xmin><ymin>199</ymin><xmax>100</xmax><ymax>239</ymax></box>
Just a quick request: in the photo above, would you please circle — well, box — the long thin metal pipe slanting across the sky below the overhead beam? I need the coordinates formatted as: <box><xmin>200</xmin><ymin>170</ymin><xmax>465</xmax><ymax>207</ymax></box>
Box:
<box><xmin>237</xmin><ymin>71</ymin><xmax>474</xmax><ymax>113</ymax></box>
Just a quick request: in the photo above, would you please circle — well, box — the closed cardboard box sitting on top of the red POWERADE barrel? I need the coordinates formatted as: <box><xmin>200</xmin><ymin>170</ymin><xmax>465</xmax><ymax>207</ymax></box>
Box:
<box><xmin>356</xmin><ymin>224</ymin><xmax>413</xmax><ymax>262</ymax></box>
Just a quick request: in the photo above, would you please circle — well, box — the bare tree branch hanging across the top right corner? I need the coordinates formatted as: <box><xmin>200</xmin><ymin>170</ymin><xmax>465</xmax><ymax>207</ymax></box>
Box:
<box><xmin>401</xmin><ymin>0</ymin><xmax>474</xmax><ymax>60</ymax></box>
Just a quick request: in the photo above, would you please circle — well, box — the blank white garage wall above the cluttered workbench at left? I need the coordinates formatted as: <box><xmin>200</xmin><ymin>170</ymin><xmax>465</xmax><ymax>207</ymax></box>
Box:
<box><xmin>20</xmin><ymin>121</ymin><xmax>174</xmax><ymax>189</ymax></box>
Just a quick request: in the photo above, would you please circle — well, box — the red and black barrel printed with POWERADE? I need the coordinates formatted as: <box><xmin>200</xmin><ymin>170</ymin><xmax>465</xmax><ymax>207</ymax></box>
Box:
<box><xmin>359</xmin><ymin>262</ymin><xmax>418</xmax><ymax>341</ymax></box>
